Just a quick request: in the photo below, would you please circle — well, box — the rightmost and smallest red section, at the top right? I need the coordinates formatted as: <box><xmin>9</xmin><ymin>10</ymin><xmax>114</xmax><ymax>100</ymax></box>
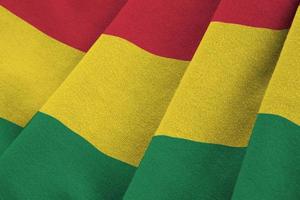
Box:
<box><xmin>213</xmin><ymin>0</ymin><xmax>299</xmax><ymax>29</ymax></box>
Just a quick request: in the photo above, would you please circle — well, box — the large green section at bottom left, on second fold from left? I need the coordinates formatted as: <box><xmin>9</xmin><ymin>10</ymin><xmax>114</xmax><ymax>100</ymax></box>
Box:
<box><xmin>0</xmin><ymin>113</ymin><xmax>135</xmax><ymax>200</ymax></box>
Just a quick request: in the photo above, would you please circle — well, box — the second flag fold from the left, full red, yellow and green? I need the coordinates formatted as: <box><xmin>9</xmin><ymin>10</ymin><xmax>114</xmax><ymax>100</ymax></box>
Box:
<box><xmin>0</xmin><ymin>0</ymin><xmax>218</xmax><ymax>199</ymax></box>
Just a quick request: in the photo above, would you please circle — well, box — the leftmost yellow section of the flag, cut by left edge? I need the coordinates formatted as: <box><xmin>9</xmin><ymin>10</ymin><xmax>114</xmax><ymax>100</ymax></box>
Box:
<box><xmin>0</xmin><ymin>6</ymin><xmax>83</xmax><ymax>126</ymax></box>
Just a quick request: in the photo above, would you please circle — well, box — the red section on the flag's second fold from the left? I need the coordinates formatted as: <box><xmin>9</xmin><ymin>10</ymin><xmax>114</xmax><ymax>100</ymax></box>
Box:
<box><xmin>105</xmin><ymin>0</ymin><xmax>219</xmax><ymax>60</ymax></box>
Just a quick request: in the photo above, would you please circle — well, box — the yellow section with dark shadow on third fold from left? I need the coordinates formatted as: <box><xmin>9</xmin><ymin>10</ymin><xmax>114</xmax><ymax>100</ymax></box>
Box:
<box><xmin>157</xmin><ymin>22</ymin><xmax>286</xmax><ymax>147</ymax></box>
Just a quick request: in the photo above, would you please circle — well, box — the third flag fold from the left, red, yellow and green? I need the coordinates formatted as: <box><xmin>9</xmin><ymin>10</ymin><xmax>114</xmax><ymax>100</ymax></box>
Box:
<box><xmin>124</xmin><ymin>0</ymin><xmax>298</xmax><ymax>200</ymax></box>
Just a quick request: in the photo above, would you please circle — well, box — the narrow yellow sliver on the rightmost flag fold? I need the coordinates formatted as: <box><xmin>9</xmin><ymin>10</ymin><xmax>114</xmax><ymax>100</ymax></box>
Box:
<box><xmin>259</xmin><ymin>8</ymin><xmax>300</xmax><ymax>124</ymax></box>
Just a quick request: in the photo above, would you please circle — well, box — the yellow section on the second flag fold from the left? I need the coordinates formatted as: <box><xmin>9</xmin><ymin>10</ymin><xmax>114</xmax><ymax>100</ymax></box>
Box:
<box><xmin>41</xmin><ymin>35</ymin><xmax>188</xmax><ymax>166</ymax></box>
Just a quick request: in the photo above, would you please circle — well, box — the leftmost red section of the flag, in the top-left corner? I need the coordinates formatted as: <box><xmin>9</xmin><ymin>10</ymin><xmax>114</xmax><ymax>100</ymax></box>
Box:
<box><xmin>1</xmin><ymin>0</ymin><xmax>126</xmax><ymax>51</ymax></box>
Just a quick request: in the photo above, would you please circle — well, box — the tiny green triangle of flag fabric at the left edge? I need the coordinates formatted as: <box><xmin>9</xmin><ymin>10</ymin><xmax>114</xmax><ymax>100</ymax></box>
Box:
<box><xmin>0</xmin><ymin>118</ymin><xmax>23</xmax><ymax>155</ymax></box>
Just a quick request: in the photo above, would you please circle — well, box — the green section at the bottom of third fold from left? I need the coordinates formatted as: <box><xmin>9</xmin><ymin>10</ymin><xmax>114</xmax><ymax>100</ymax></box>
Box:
<box><xmin>124</xmin><ymin>136</ymin><xmax>245</xmax><ymax>200</ymax></box>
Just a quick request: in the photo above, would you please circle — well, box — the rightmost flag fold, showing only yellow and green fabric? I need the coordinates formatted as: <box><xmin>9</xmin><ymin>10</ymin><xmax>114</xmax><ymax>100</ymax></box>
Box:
<box><xmin>232</xmin><ymin>4</ymin><xmax>300</xmax><ymax>200</ymax></box>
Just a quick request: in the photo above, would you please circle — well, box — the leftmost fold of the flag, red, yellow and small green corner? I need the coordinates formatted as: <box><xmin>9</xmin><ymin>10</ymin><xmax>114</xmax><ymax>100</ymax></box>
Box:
<box><xmin>0</xmin><ymin>0</ymin><xmax>125</xmax><ymax>154</ymax></box>
